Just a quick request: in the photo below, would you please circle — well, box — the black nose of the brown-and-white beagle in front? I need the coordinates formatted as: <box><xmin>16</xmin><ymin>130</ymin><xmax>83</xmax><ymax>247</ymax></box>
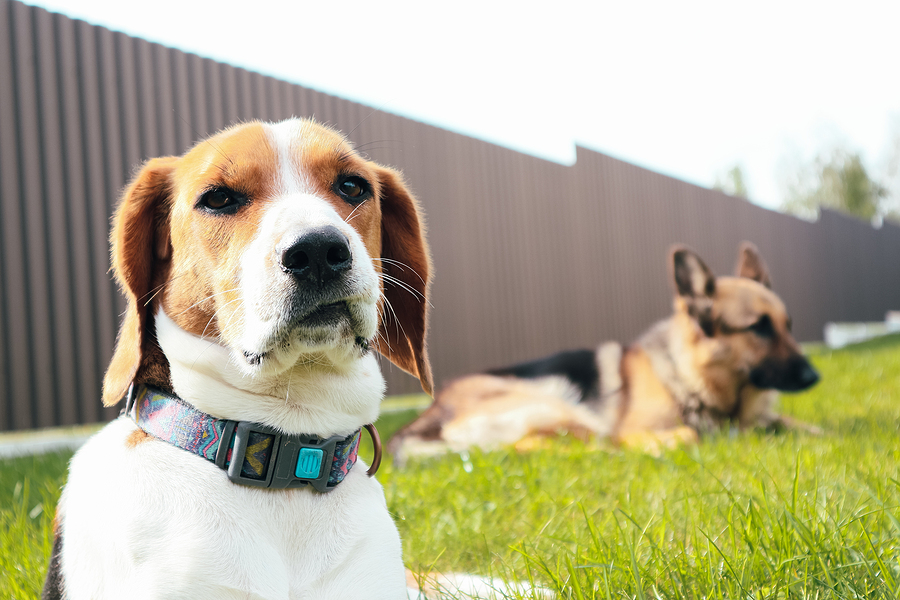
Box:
<box><xmin>281</xmin><ymin>225</ymin><xmax>353</xmax><ymax>283</ymax></box>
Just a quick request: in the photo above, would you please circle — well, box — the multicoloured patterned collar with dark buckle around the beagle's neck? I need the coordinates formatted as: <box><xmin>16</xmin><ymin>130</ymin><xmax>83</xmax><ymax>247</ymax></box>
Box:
<box><xmin>123</xmin><ymin>384</ymin><xmax>381</xmax><ymax>492</ymax></box>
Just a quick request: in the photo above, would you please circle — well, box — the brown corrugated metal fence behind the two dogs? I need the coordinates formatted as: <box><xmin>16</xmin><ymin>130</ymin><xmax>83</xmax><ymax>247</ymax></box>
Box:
<box><xmin>0</xmin><ymin>0</ymin><xmax>900</xmax><ymax>430</ymax></box>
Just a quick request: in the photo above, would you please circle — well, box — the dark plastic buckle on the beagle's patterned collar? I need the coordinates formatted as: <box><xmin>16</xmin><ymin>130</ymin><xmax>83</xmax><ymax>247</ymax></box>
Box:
<box><xmin>216</xmin><ymin>421</ymin><xmax>346</xmax><ymax>492</ymax></box>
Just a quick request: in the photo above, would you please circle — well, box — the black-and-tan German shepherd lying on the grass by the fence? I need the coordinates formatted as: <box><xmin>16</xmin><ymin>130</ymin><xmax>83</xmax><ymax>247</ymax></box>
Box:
<box><xmin>389</xmin><ymin>242</ymin><xmax>819</xmax><ymax>463</ymax></box>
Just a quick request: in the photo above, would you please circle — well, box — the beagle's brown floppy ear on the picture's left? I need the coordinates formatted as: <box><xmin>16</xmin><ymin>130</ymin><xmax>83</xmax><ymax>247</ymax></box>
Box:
<box><xmin>103</xmin><ymin>157</ymin><xmax>178</xmax><ymax>406</ymax></box>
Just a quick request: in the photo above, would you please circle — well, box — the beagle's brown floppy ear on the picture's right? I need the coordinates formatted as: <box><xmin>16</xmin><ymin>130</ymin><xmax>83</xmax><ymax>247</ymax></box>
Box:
<box><xmin>377</xmin><ymin>167</ymin><xmax>432</xmax><ymax>394</ymax></box>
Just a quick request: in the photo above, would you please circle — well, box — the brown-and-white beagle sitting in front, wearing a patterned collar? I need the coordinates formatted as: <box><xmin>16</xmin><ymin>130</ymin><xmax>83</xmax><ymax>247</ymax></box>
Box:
<box><xmin>43</xmin><ymin>119</ymin><xmax>432</xmax><ymax>600</ymax></box>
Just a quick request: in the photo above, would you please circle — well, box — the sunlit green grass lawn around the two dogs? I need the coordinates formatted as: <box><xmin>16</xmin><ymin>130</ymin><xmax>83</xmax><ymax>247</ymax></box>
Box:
<box><xmin>0</xmin><ymin>336</ymin><xmax>900</xmax><ymax>600</ymax></box>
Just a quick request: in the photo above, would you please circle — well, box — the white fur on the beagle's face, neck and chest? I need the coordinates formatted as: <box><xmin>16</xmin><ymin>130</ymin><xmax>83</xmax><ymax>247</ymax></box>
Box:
<box><xmin>58</xmin><ymin>121</ymin><xmax>420</xmax><ymax>600</ymax></box>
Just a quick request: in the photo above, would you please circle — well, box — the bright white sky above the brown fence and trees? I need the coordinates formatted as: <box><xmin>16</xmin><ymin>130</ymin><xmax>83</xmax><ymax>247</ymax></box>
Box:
<box><xmin>21</xmin><ymin>0</ymin><xmax>900</xmax><ymax>207</ymax></box>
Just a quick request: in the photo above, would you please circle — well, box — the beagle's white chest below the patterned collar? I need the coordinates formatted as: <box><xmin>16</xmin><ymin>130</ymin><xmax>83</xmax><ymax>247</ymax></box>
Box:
<box><xmin>61</xmin><ymin>418</ymin><xmax>405</xmax><ymax>600</ymax></box>
